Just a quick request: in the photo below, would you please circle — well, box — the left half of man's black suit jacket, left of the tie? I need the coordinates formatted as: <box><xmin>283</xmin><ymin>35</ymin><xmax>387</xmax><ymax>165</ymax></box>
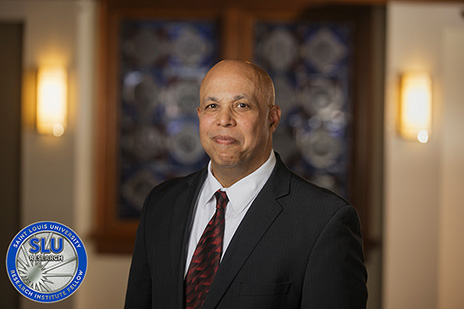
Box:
<box><xmin>125</xmin><ymin>169</ymin><xmax>206</xmax><ymax>308</ymax></box>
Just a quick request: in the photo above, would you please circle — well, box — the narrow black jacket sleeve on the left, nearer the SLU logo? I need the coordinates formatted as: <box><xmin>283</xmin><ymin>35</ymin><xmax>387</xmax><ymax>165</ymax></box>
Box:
<box><xmin>124</xmin><ymin>191</ymin><xmax>153</xmax><ymax>309</ymax></box>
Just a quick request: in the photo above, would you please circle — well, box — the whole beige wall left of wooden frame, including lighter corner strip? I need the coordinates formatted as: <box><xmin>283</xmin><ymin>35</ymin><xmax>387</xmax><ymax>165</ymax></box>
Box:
<box><xmin>0</xmin><ymin>0</ymin><xmax>130</xmax><ymax>309</ymax></box>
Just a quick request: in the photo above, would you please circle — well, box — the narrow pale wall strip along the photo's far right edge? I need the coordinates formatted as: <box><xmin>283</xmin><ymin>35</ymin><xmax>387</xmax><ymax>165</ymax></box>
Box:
<box><xmin>438</xmin><ymin>26</ymin><xmax>464</xmax><ymax>309</ymax></box>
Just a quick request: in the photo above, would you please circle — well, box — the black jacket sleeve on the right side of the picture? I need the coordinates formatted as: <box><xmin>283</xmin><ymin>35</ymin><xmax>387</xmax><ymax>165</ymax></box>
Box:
<box><xmin>301</xmin><ymin>206</ymin><xmax>367</xmax><ymax>309</ymax></box>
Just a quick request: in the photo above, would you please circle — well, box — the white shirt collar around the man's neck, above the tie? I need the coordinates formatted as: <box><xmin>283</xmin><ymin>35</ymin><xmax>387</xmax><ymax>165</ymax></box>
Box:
<box><xmin>202</xmin><ymin>151</ymin><xmax>276</xmax><ymax>215</ymax></box>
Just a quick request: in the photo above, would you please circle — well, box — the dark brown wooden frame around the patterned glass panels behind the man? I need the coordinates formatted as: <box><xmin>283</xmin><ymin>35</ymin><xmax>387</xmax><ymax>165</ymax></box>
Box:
<box><xmin>94</xmin><ymin>2</ymin><xmax>378</xmax><ymax>254</ymax></box>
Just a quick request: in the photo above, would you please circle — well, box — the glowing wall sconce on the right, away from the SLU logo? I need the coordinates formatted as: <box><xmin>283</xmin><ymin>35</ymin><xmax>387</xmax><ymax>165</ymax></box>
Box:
<box><xmin>398</xmin><ymin>72</ymin><xmax>432</xmax><ymax>143</ymax></box>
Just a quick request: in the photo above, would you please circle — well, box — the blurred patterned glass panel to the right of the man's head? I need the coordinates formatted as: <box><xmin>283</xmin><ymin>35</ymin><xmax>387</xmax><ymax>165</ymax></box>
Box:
<box><xmin>254</xmin><ymin>22</ymin><xmax>352</xmax><ymax>196</ymax></box>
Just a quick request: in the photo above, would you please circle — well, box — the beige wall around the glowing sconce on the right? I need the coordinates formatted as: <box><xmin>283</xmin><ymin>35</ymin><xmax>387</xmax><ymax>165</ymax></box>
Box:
<box><xmin>383</xmin><ymin>2</ymin><xmax>464</xmax><ymax>309</ymax></box>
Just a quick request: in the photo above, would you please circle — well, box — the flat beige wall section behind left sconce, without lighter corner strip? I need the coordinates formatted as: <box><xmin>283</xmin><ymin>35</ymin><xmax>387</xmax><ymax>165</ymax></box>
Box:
<box><xmin>0</xmin><ymin>1</ymin><xmax>77</xmax><ymax>308</ymax></box>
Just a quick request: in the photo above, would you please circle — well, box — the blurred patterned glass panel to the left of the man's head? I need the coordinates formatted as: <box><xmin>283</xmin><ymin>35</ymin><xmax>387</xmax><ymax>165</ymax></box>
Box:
<box><xmin>117</xmin><ymin>19</ymin><xmax>218</xmax><ymax>219</ymax></box>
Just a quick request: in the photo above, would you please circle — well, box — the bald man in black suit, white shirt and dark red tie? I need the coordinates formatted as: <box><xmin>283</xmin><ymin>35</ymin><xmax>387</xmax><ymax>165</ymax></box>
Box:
<box><xmin>126</xmin><ymin>60</ymin><xmax>367</xmax><ymax>309</ymax></box>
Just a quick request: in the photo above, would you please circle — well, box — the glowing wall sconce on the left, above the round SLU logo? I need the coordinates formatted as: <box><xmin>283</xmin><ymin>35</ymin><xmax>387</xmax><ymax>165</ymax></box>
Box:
<box><xmin>37</xmin><ymin>66</ymin><xmax>68</xmax><ymax>137</ymax></box>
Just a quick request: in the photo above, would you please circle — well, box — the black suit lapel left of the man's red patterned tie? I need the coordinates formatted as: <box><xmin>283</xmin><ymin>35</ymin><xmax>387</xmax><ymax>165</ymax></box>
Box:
<box><xmin>170</xmin><ymin>170</ymin><xmax>206</xmax><ymax>308</ymax></box>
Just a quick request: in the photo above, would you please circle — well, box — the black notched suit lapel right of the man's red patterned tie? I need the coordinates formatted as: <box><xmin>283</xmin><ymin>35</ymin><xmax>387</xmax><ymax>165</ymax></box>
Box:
<box><xmin>203</xmin><ymin>156</ymin><xmax>290</xmax><ymax>308</ymax></box>
